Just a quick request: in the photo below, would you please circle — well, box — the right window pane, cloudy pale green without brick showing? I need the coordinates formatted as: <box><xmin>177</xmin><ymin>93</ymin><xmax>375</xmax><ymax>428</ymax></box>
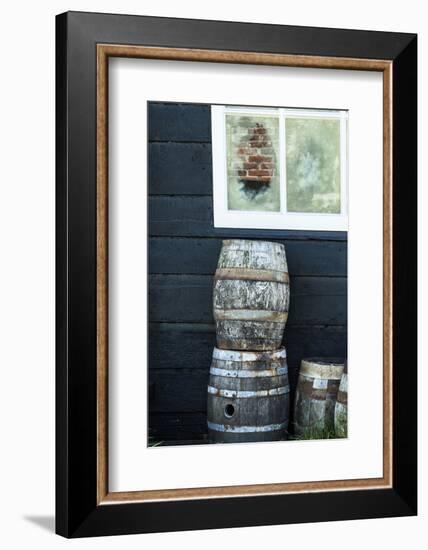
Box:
<box><xmin>285</xmin><ymin>117</ymin><xmax>340</xmax><ymax>214</ymax></box>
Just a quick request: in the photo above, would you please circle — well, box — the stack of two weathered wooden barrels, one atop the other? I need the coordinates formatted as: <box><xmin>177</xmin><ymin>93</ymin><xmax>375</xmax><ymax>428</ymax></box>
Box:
<box><xmin>207</xmin><ymin>240</ymin><xmax>290</xmax><ymax>443</ymax></box>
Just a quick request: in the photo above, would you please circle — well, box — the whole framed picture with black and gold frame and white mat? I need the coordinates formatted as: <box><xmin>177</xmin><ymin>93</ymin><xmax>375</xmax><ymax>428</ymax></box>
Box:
<box><xmin>56</xmin><ymin>12</ymin><xmax>417</xmax><ymax>537</ymax></box>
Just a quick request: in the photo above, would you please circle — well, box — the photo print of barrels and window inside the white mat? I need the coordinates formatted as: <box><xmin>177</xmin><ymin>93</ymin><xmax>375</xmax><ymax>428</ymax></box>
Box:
<box><xmin>147</xmin><ymin>102</ymin><xmax>348</xmax><ymax>447</ymax></box>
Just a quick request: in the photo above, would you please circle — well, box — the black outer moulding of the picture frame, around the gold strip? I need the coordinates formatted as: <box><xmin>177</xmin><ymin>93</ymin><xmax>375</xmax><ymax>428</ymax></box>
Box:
<box><xmin>56</xmin><ymin>12</ymin><xmax>417</xmax><ymax>537</ymax></box>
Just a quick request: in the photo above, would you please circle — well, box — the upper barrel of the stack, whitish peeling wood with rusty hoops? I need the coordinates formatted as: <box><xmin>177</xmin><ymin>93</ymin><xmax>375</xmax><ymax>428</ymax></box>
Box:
<box><xmin>213</xmin><ymin>240</ymin><xmax>290</xmax><ymax>351</ymax></box>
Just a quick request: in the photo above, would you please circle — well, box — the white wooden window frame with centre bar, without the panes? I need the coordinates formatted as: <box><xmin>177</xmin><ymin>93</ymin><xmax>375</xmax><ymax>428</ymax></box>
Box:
<box><xmin>211</xmin><ymin>105</ymin><xmax>348</xmax><ymax>231</ymax></box>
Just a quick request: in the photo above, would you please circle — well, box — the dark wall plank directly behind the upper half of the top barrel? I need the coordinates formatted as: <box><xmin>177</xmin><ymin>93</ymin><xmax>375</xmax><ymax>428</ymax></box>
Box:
<box><xmin>149</xmin><ymin>237</ymin><xmax>347</xmax><ymax>276</ymax></box>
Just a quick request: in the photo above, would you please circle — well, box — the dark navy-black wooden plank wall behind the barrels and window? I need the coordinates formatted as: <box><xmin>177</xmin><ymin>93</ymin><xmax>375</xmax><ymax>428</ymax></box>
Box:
<box><xmin>149</xmin><ymin>103</ymin><xmax>347</xmax><ymax>441</ymax></box>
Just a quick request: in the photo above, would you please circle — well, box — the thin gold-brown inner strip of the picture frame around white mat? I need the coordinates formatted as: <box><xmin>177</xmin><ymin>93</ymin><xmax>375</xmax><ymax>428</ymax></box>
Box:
<box><xmin>97</xmin><ymin>44</ymin><xmax>392</xmax><ymax>505</ymax></box>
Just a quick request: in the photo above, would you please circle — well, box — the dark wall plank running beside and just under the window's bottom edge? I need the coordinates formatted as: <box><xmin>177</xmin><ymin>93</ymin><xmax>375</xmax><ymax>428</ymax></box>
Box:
<box><xmin>149</xmin><ymin>195</ymin><xmax>347</xmax><ymax>241</ymax></box>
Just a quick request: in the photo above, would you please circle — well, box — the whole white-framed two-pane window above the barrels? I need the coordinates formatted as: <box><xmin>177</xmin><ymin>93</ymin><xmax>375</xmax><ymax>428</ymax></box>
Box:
<box><xmin>211</xmin><ymin>105</ymin><xmax>348</xmax><ymax>231</ymax></box>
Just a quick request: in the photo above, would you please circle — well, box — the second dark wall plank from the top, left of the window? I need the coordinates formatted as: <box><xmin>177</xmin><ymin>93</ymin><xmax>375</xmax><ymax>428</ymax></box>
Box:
<box><xmin>149</xmin><ymin>142</ymin><xmax>212</xmax><ymax>195</ymax></box>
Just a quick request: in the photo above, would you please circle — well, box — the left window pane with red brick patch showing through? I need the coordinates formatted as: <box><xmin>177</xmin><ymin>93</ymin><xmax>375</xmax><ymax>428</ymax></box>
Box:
<box><xmin>226</xmin><ymin>113</ymin><xmax>280</xmax><ymax>212</ymax></box>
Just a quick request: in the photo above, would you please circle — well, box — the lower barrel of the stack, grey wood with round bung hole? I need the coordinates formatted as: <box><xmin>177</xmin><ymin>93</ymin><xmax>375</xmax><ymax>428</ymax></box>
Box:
<box><xmin>207</xmin><ymin>348</ymin><xmax>290</xmax><ymax>443</ymax></box>
